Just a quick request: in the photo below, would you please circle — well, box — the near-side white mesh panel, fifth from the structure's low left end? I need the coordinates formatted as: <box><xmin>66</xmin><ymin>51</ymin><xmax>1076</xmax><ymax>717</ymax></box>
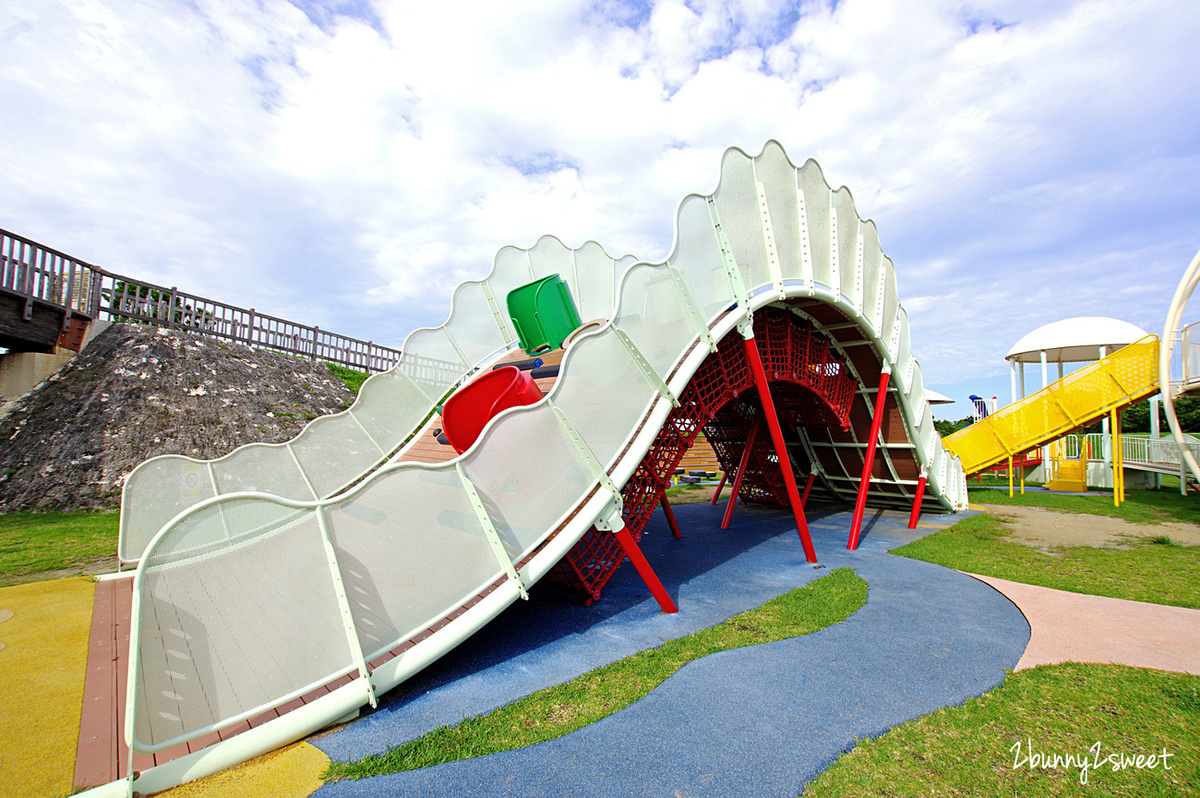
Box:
<box><xmin>613</xmin><ymin>263</ymin><xmax>696</xmax><ymax>379</ymax></box>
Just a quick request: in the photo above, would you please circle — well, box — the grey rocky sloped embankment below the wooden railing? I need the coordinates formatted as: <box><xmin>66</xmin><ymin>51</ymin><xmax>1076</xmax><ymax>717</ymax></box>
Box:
<box><xmin>0</xmin><ymin>324</ymin><xmax>354</xmax><ymax>511</ymax></box>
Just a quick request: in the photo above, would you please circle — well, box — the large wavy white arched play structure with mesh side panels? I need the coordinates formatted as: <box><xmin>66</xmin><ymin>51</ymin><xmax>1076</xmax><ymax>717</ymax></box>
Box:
<box><xmin>103</xmin><ymin>142</ymin><xmax>966</xmax><ymax>792</ymax></box>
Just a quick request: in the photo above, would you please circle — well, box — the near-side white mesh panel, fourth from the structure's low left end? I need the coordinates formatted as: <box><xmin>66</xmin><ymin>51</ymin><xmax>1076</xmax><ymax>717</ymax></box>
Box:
<box><xmin>554</xmin><ymin>328</ymin><xmax>658</xmax><ymax>470</ymax></box>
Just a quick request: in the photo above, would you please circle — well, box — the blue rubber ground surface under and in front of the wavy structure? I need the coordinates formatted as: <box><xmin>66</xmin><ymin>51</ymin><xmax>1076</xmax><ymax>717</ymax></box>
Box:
<box><xmin>313</xmin><ymin>504</ymin><xmax>1030</xmax><ymax>797</ymax></box>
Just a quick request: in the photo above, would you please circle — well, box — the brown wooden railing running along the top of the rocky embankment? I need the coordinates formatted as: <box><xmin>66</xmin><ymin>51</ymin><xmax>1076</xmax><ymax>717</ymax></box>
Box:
<box><xmin>0</xmin><ymin>229</ymin><xmax>400</xmax><ymax>372</ymax></box>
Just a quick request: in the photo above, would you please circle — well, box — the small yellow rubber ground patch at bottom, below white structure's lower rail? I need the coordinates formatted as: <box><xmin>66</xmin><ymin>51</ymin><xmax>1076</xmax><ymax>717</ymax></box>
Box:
<box><xmin>158</xmin><ymin>743</ymin><xmax>329</xmax><ymax>798</ymax></box>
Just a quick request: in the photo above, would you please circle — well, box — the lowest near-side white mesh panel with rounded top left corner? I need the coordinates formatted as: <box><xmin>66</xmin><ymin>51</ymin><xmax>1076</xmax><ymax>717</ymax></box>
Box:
<box><xmin>136</xmin><ymin>500</ymin><xmax>353</xmax><ymax>746</ymax></box>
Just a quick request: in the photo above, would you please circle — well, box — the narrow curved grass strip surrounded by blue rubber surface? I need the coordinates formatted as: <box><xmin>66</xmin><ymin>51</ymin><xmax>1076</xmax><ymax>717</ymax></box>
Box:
<box><xmin>325</xmin><ymin>568</ymin><xmax>866</xmax><ymax>779</ymax></box>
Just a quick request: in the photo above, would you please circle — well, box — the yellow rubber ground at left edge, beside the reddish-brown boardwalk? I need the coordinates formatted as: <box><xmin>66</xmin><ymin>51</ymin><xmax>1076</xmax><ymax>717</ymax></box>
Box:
<box><xmin>0</xmin><ymin>577</ymin><xmax>96</xmax><ymax>798</ymax></box>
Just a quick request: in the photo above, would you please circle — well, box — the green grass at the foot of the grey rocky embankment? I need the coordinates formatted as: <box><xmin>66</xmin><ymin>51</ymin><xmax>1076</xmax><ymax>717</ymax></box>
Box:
<box><xmin>0</xmin><ymin>512</ymin><xmax>118</xmax><ymax>587</ymax></box>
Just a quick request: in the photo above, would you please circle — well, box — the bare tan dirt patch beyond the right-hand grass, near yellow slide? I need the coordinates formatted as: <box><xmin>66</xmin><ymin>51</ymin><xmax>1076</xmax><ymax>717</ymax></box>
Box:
<box><xmin>978</xmin><ymin>504</ymin><xmax>1200</xmax><ymax>551</ymax></box>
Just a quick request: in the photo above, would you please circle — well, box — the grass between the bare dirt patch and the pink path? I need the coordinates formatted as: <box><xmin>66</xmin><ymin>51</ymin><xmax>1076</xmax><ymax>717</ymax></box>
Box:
<box><xmin>893</xmin><ymin>513</ymin><xmax>1200</xmax><ymax>608</ymax></box>
